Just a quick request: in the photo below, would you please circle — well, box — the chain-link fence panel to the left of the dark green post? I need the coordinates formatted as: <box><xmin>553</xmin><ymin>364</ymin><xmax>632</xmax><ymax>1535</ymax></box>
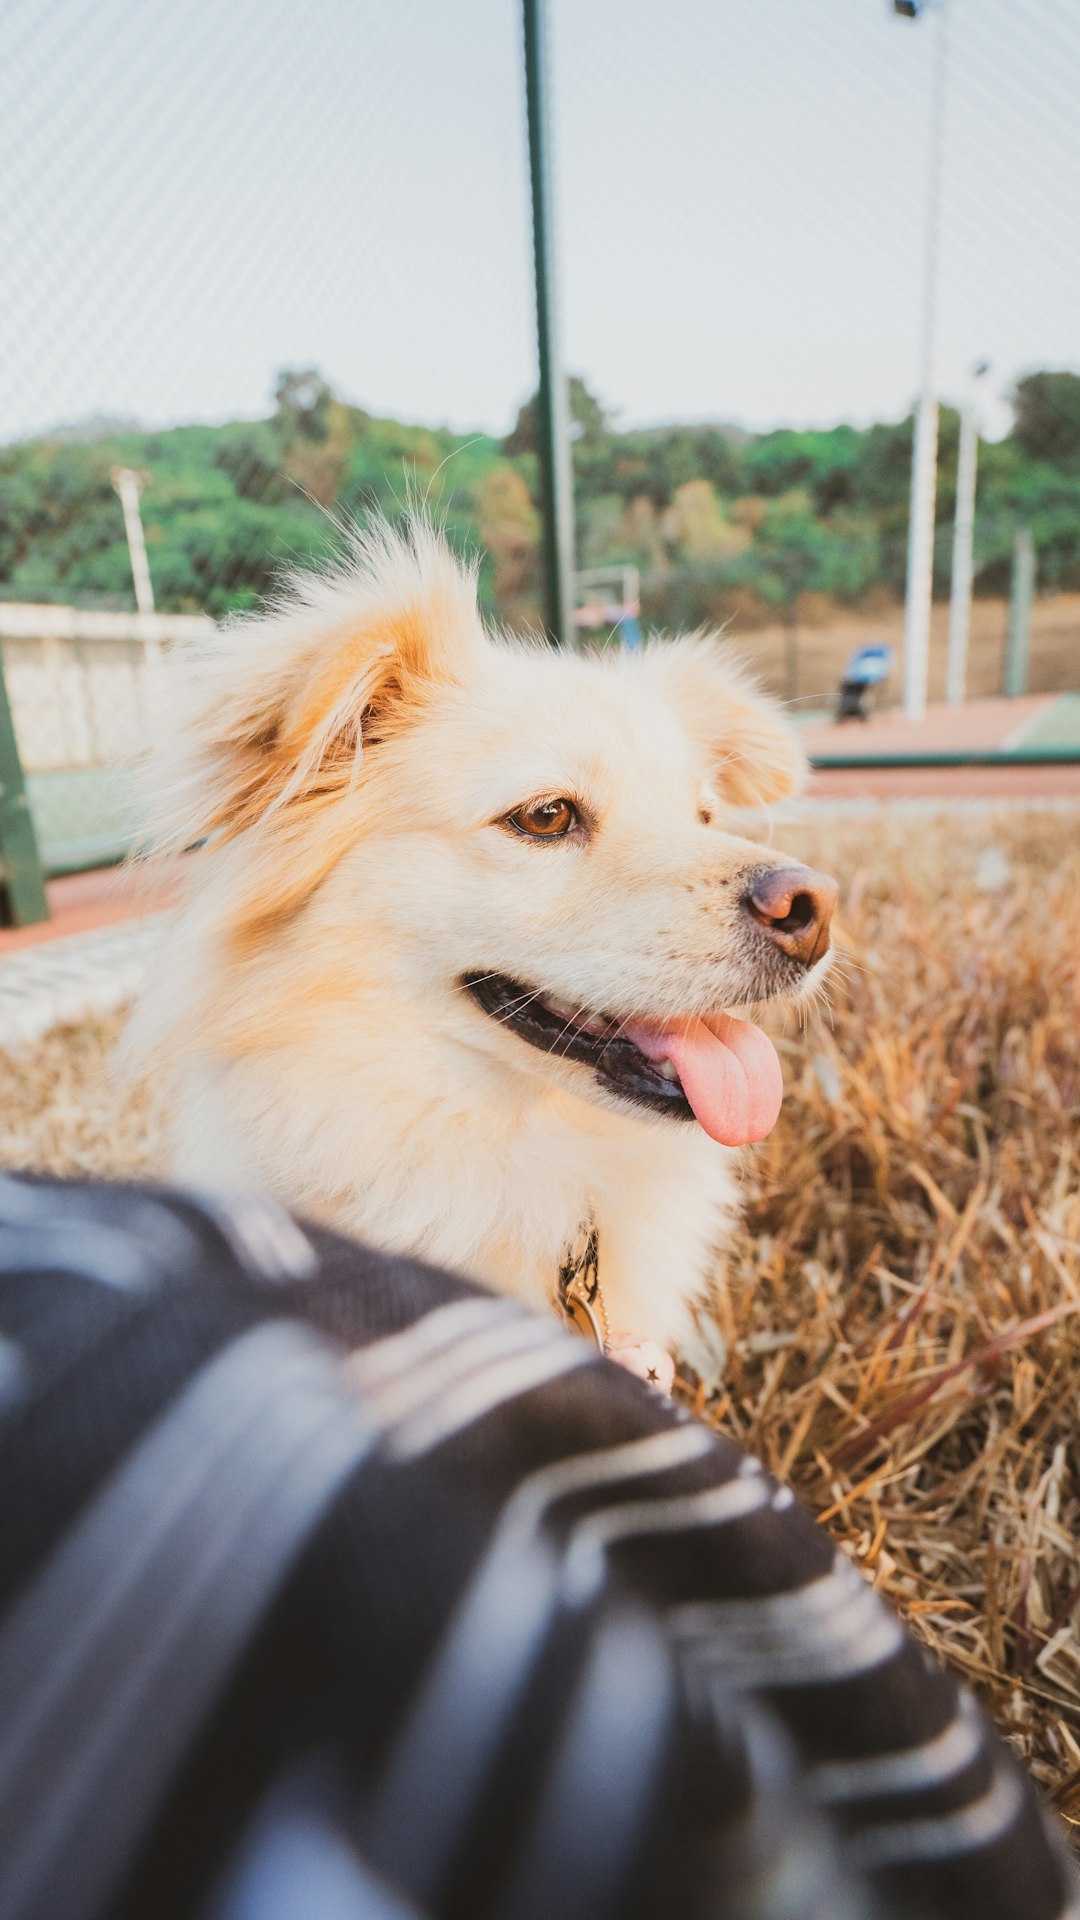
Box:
<box><xmin>0</xmin><ymin>0</ymin><xmax>536</xmax><ymax>883</ymax></box>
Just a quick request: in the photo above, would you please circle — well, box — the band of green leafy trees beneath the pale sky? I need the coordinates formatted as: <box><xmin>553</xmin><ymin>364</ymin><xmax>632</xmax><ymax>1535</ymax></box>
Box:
<box><xmin>0</xmin><ymin>369</ymin><xmax>1080</xmax><ymax>624</ymax></box>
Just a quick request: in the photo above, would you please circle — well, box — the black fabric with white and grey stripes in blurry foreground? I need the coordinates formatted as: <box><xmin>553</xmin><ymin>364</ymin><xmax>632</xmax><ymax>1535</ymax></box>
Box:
<box><xmin>0</xmin><ymin>1179</ymin><xmax>1080</xmax><ymax>1920</ymax></box>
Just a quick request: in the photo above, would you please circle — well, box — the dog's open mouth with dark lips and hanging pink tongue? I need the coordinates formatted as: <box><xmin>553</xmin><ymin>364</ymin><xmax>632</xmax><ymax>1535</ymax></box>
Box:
<box><xmin>461</xmin><ymin>973</ymin><xmax>784</xmax><ymax>1146</ymax></box>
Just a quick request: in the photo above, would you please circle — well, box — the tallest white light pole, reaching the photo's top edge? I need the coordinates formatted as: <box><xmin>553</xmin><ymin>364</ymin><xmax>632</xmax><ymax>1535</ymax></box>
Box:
<box><xmin>894</xmin><ymin>0</ymin><xmax>945</xmax><ymax>720</ymax></box>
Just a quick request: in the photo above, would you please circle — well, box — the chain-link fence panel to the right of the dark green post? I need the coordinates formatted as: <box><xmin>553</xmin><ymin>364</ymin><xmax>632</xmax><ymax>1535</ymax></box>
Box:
<box><xmin>553</xmin><ymin>0</ymin><xmax>1080</xmax><ymax>721</ymax></box>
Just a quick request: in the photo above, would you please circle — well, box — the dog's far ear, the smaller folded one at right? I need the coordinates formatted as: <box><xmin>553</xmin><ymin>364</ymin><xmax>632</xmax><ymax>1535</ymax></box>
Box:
<box><xmin>650</xmin><ymin>634</ymin><xmax>809</xmax><ymax>806</ymax></box>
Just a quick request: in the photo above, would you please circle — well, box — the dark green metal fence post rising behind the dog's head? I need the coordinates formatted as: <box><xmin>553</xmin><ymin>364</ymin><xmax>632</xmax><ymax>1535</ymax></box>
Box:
<box><xmin>523</xmin><ymin>0</ymin><xmax>577</xmax><ymax>647</ymax></box>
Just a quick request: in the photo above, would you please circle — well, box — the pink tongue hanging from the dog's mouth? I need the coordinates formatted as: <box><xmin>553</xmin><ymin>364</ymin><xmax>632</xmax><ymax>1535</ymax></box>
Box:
<box><xmin>626</xmin><ymin>1014</ymin><xmax>784</xmax><ymax>1146</ymax></box>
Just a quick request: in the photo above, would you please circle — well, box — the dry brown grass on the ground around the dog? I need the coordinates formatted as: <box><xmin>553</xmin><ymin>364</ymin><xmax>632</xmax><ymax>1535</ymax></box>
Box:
<box><xmin>0</xmin><ymin>812</ymin><xmax>1080</xmax><ymax>1822</ymax></box>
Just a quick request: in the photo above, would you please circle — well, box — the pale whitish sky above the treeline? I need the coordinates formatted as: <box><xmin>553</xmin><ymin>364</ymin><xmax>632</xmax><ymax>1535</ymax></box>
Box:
<box><xmin>0</xmin><ymin>0</ymin><xmax>1080</xmax><ymax>438</ymax></box>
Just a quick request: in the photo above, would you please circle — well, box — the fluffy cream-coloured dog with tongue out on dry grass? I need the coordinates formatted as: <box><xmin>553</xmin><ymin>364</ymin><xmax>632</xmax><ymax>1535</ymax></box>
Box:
<box><xmin>127</xmin><ymin>522</ymin><xmax>834</xmax><ymax>1371</ymax></box>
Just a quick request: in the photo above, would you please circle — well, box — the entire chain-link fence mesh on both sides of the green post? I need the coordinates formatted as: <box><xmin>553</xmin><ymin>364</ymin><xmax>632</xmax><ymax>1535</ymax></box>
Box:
<box><xmin>0</xmin><ymin>0</ymin><xmax>1080</xmax><ymax>883</ymax></box>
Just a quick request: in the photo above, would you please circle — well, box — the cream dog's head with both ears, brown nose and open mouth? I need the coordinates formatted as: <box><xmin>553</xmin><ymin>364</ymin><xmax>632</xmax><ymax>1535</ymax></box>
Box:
<box><xmin>159</xmin><ymin>524</ymin><xmax>834</xmax><ymax>1144</ymax></box>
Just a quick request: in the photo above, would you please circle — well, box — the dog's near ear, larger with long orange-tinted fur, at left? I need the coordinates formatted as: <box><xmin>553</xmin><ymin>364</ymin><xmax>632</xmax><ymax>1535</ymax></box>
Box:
<box><xmin>145</xmin><ymin>520</ymin><xmax>486</xmax><ymax>849</ymax></box>
